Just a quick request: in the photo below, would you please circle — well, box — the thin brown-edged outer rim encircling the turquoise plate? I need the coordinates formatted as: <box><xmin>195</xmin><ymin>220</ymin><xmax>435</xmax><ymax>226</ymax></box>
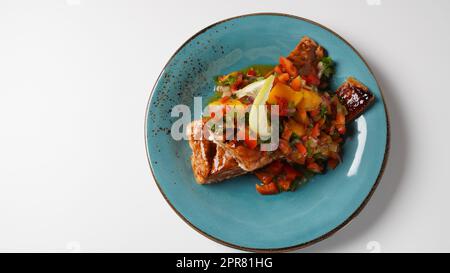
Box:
<box><xmin>144</xmin><ymin>12</ymin><xmax>390</xmax><ymax>253</ymax></box>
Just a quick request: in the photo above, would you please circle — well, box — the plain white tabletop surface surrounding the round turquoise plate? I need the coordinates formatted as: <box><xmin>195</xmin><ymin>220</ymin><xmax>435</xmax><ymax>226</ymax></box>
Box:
<box><xmin>0</xmin><ymin>0</ymin><xmax>450</xmax><ymax>252</ymax></box>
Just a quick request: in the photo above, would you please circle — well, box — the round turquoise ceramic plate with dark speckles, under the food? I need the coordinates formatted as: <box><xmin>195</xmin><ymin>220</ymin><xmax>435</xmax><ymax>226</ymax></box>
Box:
<box><xmin>145</xmin><ymin>14</ymin><xmax>389</xmax><ymax>251</ymax></box>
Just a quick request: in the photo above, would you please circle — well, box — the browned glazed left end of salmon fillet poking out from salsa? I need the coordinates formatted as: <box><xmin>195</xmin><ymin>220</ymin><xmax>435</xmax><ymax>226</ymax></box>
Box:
<box><xmin>188</xmin><ymin>119</ymin><xmax>246</xmax><ymax>184</ymax></box>
